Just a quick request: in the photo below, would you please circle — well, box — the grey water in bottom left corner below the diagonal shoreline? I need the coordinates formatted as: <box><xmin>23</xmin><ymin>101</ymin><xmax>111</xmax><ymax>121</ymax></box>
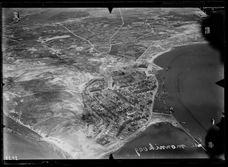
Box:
<box><xmin>3</xmin><ymin>116</ymin><xmax>68</xmax><ymax>160</ymax></box>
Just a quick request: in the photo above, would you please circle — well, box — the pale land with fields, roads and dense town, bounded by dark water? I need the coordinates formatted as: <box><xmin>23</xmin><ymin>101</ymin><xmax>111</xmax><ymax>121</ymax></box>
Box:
<box><xmin>2</xmin><ymin>8</ymin><xmax>221</xmax><ymax>159</ymax></box>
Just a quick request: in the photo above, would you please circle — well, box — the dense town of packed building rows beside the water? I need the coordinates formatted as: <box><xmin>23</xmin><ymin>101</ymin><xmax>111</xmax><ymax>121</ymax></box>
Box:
<box><xmin>83</xmin><ymin>69</ymin><xmax>157</xmax><ymax>145</ymax></box>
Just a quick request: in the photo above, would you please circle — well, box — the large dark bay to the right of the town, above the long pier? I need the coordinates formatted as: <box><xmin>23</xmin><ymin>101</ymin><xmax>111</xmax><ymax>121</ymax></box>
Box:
<box><xmin>151</xmin><ymin>42</ymin><xmax>222</xmax><ymax>144</ymax></box>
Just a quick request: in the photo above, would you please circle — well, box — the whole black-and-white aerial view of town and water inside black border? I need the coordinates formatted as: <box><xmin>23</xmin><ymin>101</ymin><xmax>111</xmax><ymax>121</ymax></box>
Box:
<box><xmin>2</xmin><ymin>8</ymin><xmax>224</xmax><ymax>160</ymax></box>
